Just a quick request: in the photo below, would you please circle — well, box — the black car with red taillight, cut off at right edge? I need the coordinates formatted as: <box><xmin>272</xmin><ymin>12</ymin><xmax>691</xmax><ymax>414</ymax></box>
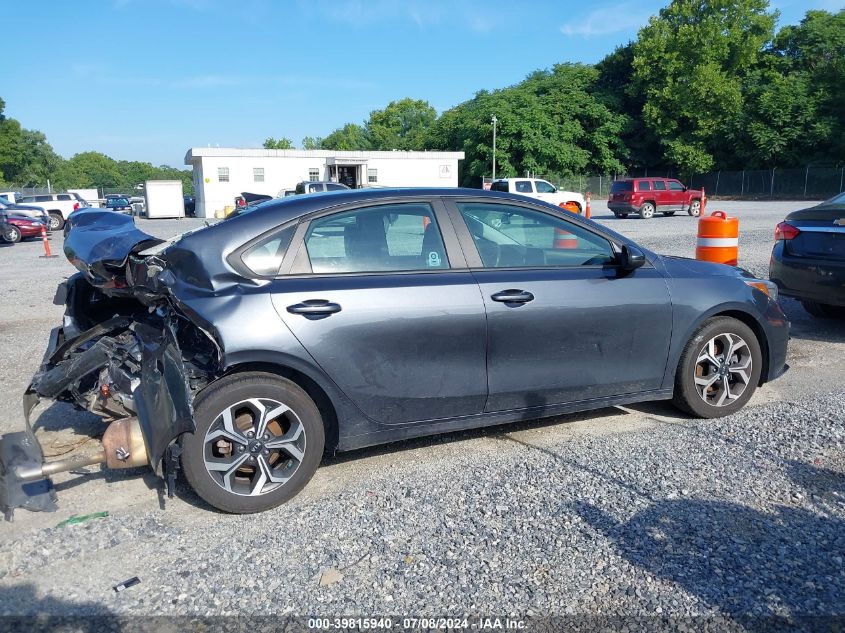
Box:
<box><xmin>769</xmin><ymin>193</ymin><xmax>845</xmax><ymax>318</ymax></box>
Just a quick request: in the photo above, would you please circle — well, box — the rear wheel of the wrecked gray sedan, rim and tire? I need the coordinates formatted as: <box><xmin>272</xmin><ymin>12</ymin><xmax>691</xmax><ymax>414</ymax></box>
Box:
<box><xmin>182</xmin><ymin>372</ymin><xmax>325</xmax><ymax>514</ymax></box>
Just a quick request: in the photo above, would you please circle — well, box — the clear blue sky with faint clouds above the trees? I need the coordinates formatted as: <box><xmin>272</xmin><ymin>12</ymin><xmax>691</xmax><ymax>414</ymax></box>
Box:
<box><xmin>0</xmin><ymin>0</ymin><xmax>843</xmax><ymax>166</ymax></box>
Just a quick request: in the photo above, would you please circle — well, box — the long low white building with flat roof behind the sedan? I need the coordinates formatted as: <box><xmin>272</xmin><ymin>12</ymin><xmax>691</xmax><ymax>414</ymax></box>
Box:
<box><xmin>185</xmin><ymin>147</ymin><xmax>464</xmax><ymax>217</ymax></box>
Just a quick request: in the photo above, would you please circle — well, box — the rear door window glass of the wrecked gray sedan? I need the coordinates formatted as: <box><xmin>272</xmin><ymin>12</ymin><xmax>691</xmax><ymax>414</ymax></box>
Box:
<box><xmin>305</xmin><ymin>202</ymin><xmax>449</xmax><ymax>273</ymax></box>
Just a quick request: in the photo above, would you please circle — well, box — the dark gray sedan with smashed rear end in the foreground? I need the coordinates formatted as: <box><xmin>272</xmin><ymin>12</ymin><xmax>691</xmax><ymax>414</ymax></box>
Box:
<box><xmin>0</xmin><ymin>189</ymin><xmax>789</xmax><ymax>516</ymax></box>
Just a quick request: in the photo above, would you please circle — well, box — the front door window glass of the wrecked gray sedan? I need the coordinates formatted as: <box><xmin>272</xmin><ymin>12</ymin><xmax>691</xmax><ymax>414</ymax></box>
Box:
<box><xmin>458</xmin><ymin>202</ymin><xmax>616</xmax><ymax>268</ymax></box>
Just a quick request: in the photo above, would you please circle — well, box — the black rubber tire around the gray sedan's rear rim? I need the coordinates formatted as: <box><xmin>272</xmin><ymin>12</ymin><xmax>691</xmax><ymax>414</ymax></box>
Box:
<box><xmin>182</xmin><ymin>372</ymin><xmax>325</xmax><ymax>514</ymax></box>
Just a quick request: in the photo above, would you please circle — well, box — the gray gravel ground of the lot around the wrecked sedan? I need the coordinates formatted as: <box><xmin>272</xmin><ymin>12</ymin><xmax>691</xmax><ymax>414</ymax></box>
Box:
<box><xmin>0</xmin><ymin>202</ymin><xmax>845</xmax><ymax>617</ymax></box>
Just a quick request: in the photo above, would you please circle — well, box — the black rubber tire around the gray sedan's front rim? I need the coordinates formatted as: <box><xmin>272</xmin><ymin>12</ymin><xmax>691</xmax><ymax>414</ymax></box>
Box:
<box><xmin>672</xmin><ymin>317</ymin><xmax>763</xmax><ymax>418</ymax></box>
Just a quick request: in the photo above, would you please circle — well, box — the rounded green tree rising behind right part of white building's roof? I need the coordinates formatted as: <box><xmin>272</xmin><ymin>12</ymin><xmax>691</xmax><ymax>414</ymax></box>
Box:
<box><xmin>366</xmin><ymin>98</ymin><xmax>437</xmax><ymax>151</ymax></box>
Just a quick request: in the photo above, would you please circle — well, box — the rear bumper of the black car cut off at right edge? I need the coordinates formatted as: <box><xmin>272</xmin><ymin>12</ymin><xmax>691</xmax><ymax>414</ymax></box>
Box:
<box><xmin>769</xmin><ymin>242</ymin><xmax>845</xmax><ymax>306</ymax></box>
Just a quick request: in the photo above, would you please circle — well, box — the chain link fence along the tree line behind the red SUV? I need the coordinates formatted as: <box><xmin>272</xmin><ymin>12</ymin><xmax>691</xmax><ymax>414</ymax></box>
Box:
<box><xmin>502</xmin><ymin>166</ymin><xmax>845</xmax><ymax>200</ymax></box>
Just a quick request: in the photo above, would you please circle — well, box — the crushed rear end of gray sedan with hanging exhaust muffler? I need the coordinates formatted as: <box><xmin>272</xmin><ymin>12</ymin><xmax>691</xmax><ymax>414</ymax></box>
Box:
<box><xmin>0</xmin><ymin>212</ymin><xmax>219</xmax><ymax>519</ymax></box>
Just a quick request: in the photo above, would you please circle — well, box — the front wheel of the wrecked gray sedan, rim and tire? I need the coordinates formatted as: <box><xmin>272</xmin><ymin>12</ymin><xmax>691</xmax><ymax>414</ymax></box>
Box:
<box><xmin>672</xmin><ymin>317</ymin><xmax>762</xmax><ymax>418</ymax></box>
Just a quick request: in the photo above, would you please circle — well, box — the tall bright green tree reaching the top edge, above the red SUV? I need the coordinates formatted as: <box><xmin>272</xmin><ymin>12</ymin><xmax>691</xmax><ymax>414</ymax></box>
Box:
<box><xmin>629</xmin><ymin>0</ymin><xmax>777</xmax><ymax>173</ymax></box>
